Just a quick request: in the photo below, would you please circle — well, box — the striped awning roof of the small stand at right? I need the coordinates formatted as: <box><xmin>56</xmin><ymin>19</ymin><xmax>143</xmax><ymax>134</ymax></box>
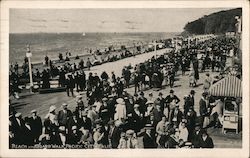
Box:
<box><xmin>209</xmin><ymin>76</ymin><xmax>242</xmax><ymax>97</ymax></box>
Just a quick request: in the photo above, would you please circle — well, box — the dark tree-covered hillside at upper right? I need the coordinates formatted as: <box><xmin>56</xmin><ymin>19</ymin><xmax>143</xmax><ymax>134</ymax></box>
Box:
<box><xmin>183</xmin><ymin>8</ymin><xmax>242</xmax><ymax>34</ymax></box>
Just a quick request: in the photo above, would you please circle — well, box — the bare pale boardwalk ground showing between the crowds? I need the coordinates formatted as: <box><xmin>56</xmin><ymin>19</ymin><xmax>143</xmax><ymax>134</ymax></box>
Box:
<box><xmin>10</xmin><ymin>47</ymin><xmax>242</xmax><ymax>148</ymax></box>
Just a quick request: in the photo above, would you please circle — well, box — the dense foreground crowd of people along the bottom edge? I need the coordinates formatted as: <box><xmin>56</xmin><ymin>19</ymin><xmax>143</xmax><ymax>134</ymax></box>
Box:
<box><xmin>9</xmin><ymin>87</ymin><xmax>218</xmax><ymax>149</ymax></box>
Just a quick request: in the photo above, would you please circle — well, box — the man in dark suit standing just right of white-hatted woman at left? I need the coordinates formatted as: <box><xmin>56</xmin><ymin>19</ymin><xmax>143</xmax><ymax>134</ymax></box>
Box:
<box><xmin>58</xmin><ymin>103</ymin><xmax>72</xmax><ymax>126</ymax></box>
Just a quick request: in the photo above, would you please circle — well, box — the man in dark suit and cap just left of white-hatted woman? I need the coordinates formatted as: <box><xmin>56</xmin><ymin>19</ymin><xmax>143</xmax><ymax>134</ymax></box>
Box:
<box><xmin>30</xmin><ymin>110</ymin><xmax>43</xmax><ymax>143</ymax></box>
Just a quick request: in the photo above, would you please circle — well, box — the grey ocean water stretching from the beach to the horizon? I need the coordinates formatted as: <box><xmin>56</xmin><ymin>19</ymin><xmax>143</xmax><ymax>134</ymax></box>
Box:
<box><xmin>9</xmin><ymin>33</ymin><xmax>177</xmax><ymax>64</ymax></box>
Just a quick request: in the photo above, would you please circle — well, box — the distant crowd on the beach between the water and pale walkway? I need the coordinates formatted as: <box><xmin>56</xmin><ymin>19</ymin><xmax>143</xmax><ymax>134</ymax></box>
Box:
<box><xmin>9</xmin><ymin>40</ymin><xmax>168</xmax><ymax>99</ymax></box>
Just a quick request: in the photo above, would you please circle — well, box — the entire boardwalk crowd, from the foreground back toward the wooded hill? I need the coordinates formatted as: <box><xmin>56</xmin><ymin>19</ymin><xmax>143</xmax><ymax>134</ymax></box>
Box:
<box><xmin>9</xmin><ymin>35</ymin><xmax>241</xmax><ymax>149</ymax></box>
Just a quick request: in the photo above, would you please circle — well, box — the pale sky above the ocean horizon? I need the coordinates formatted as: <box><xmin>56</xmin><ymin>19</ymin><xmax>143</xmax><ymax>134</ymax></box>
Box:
<box><xmin>10</xmin><ymin>8</ymin><xmax>231</xmax><ymax>33</ymax></box>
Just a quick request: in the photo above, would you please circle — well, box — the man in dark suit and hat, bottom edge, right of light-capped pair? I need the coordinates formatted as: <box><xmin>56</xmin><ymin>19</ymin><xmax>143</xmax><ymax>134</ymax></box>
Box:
<box><xmin>143</xmin><ymin>125</ymin><xmax>157</xmax><ymax>148</ymax></box>
